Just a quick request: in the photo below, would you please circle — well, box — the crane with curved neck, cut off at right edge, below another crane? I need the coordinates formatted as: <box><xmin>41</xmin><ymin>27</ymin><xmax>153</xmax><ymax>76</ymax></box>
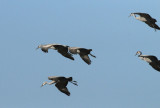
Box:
<box><xmin>136</xmin><ymin>51</ymin><xmax>160</xmax><ymax>71</ymax></box>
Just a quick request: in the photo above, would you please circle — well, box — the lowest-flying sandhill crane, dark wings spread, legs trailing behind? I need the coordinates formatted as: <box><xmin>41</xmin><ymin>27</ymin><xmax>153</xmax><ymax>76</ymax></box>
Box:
<box><xmin>41</xmin><ymin>76</ymin><xmax>78</xmax><ymax>96</ymax></box>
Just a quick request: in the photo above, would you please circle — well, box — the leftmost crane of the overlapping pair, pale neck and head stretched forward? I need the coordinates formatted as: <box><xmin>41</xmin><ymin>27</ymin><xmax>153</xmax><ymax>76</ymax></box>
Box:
<box><xmin>37</xmin><ymin>44</ymin><xmax>74</xmax><ymax>60</ymax></box>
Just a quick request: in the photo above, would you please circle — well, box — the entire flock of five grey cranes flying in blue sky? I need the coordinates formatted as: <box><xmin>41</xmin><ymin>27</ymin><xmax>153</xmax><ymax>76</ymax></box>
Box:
<box><xmin>37</xmin><ymin>13</ymin><xmax>160</xmax><ymax>96</ymax></box>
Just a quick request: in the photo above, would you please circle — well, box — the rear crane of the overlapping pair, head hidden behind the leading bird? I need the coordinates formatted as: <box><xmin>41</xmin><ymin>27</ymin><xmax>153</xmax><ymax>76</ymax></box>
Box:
<box><xmin>68</xmin><ymin>47</ymin><xmax>96</xmax><ymax>65</ymax></box>
